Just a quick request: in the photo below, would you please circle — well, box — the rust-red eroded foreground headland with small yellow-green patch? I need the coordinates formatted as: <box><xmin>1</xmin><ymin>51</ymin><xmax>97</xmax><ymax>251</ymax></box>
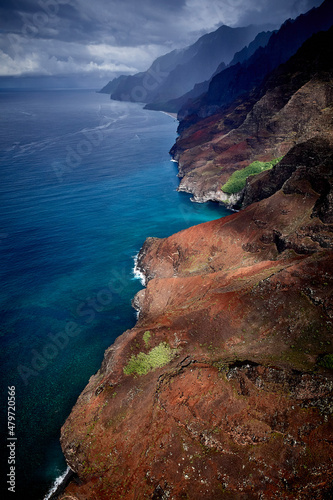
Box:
<box><xmin>61</xmin><ymin>139</ymin><xmax>333</xmax><ymax>500</ymax></box>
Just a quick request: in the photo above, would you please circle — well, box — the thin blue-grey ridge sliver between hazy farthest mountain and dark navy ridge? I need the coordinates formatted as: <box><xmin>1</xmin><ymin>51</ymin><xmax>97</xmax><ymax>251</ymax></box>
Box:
<box><xmin>145</xmin><ymin>31</ymin><xmax>273</xmax><ymax>113</ymax></box>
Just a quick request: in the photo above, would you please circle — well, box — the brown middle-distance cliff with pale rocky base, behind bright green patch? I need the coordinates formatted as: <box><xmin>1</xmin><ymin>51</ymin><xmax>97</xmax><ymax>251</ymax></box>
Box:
<box><xmin>171</xmin><ymin>24</ymin><xmax>333</xmax><ymax>205</ymax></box>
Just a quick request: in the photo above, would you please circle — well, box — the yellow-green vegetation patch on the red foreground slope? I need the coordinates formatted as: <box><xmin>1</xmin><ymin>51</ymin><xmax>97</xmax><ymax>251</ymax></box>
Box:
<box><xmin>124</xmin><ymin>342</ymin><xmax>176</xmax><ymax>375</ymax></box>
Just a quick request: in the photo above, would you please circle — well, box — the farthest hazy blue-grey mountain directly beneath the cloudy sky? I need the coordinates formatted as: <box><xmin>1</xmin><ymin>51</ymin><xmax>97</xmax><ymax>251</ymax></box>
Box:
<box><xmin>103</xmin><ymin>25</ymin><xmax>272</xmax><ymax>107</ymax></box>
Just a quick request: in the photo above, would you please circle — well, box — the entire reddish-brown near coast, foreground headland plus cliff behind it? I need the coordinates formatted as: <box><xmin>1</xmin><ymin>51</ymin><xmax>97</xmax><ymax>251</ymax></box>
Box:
<box><xmin>60</xmin><ymin>14</ymin><xmax>333</xmax><ymax>500</ymax></box>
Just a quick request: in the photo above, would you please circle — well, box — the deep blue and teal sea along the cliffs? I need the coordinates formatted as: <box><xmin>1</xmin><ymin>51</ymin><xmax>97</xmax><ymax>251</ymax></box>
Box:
<box><xmin>0</xmin><ymin>90</ymin><xmax>229</xmax><ymax>500</ymax></box>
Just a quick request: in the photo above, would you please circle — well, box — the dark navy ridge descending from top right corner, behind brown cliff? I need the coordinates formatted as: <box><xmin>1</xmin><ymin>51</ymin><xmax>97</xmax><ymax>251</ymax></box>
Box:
<box><xmin>178</xmin><ymin>0</ymin><xmax>333</xmax><ymax>124</ymax></box>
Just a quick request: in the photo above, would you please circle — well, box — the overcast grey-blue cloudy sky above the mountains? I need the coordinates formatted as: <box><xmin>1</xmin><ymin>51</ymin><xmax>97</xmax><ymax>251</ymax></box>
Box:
<box><xmin>0</xmin><ymin>0</ymin><xmax>323</xmax><ymax>88</ymax></box>
